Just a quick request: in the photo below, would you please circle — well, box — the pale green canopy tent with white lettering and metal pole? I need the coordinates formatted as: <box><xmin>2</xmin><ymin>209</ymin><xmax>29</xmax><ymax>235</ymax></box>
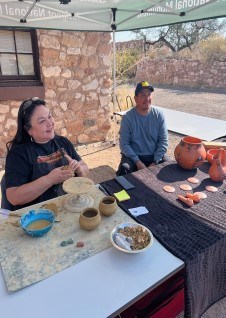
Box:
<box><xmin>0</xmin><ymin>0</ymin><xmax>226</xmax><ymax>140</ymax></box>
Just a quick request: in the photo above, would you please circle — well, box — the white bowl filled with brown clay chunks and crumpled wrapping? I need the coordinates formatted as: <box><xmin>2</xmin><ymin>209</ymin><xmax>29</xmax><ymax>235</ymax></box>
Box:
<box><xmin>110</xmin><ymin>222</ymin><xmax>154</xmax><ymax>254</ymax></box>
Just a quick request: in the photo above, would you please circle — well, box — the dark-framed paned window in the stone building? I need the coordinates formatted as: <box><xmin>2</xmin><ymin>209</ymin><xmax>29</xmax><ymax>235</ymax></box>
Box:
<box><xmin>0</xmin><ymin>29</ymin><xmax>42</xmax><ymax>100</ymax></box>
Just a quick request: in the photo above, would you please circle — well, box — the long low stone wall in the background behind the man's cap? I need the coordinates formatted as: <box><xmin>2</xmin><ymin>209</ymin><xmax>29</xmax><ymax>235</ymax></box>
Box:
<box><xmin>136</xmin><ymin>58</ymin><xmax>226</xmax><ymax>90</ymax></box>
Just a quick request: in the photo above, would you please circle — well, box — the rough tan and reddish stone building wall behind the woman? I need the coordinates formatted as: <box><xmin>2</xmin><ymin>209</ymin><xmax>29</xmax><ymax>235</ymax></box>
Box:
<box><xmin>0</xmin><ymin>30</ymin><xmax>112</xmax><ymax>170</ymax></box>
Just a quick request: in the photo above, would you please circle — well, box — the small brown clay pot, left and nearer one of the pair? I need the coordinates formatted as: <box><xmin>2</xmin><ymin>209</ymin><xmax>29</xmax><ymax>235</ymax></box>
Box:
<box><xmin>79</xmin><ymin>208</ymin><xmax>101</xmax><ymax>231</ymax></box>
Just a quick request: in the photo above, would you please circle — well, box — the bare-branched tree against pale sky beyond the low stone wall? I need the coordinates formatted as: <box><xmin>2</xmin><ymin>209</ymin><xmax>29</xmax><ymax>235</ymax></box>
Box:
<box><xmin>133</xmin><ymin>19</ymin><xmax>226</xmax><ymax>55</ymax></box>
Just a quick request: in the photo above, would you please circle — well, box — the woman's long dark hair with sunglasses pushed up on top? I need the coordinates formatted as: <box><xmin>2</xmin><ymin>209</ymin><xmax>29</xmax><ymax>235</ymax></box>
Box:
<box><xmin>6</xmin><ymin>97</ymin><xmax>46</xmax><ymax>152</ymax></box>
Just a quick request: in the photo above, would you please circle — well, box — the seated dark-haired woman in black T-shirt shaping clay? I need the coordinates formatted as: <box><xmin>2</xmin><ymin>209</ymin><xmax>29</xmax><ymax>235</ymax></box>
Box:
<box><xmin>5</xmin><ymin>97</ymin><xmax>89</xmax><ymax>210</ymax></box>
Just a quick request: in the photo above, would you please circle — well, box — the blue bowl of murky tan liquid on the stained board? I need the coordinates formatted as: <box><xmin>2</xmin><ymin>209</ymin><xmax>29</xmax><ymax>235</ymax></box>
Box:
<box><xmin>20</xmin><ymin>209</ymin><xmax>55</xmax><ymax>237</ymax></box>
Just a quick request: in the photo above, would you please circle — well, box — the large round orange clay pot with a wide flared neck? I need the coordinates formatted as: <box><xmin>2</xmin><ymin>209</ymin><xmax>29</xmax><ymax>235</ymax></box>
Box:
<box><xmin>174</xmin><ymin>136</ymin><xmax>206</xmax><ymax>170</ymax></box>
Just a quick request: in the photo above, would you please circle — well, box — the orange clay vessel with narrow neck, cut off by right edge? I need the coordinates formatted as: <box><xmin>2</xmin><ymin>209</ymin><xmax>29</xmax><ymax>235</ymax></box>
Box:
<box><xmin>209</xmin><ymin>148</ymin><xmax>226</xmax><ymax>182</ymax></box>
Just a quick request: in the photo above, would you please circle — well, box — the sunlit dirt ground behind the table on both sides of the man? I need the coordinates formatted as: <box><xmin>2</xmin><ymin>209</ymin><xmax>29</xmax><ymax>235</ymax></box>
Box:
<box><xmin>81</xmin><ymin>87</ymin><xmax>226</xmax><ymax>183</ymax></box>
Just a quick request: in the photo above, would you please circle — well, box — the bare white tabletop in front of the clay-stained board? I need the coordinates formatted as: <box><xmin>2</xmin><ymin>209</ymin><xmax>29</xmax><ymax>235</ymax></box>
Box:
<box><xmin>0</xmin><ymin>239</ymin><xmax>184</xmax><ymax>318</ymax></box>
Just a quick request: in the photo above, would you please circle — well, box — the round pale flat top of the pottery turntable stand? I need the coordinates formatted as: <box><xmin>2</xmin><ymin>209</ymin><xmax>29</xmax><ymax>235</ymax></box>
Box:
<box><xmin>62</xmin><ymin>177</ymin><xmax>94</xmax><ymax>194</ymax></box>
